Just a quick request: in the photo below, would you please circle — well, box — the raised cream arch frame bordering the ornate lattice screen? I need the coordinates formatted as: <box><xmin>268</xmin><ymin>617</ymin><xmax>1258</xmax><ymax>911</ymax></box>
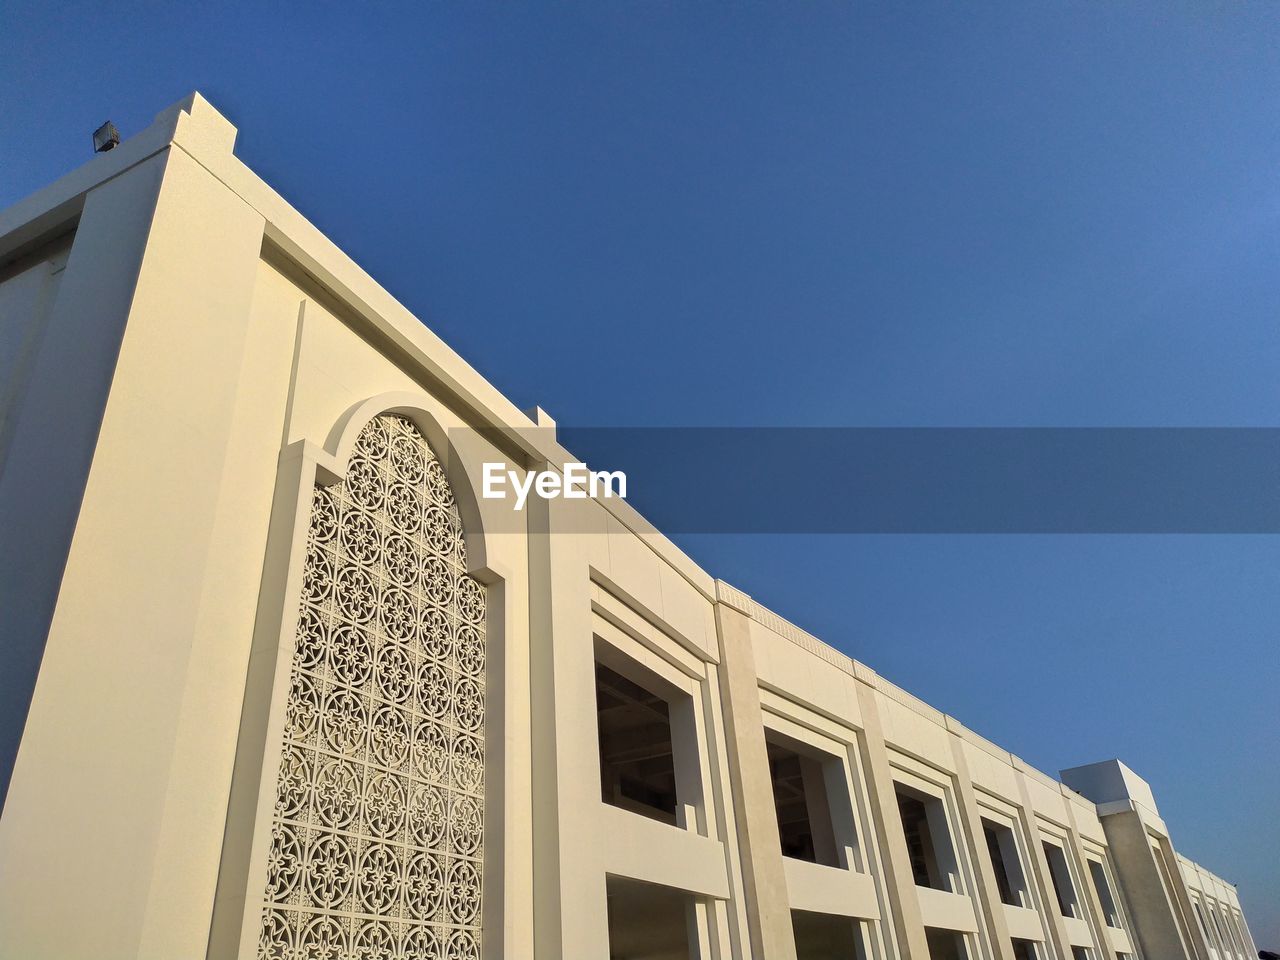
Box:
<box><xmin>206</xmin><ymin>390</ymin><xmax>515</xmax><ymax>960</ymax></box>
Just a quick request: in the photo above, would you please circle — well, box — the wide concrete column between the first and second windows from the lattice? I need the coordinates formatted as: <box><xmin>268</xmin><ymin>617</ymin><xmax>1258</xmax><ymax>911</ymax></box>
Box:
<box><xmin>716</xmin><ymin>602</ymin><xmax>796</xmax><ymax>960</ymax></box>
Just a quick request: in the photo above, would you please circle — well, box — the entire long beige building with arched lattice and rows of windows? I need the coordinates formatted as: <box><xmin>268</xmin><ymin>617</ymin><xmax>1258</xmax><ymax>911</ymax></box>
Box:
<box><xmin>0</xmin><ymin>96</ymin><xmax>1257</xmax><ymax>960</ymax></box>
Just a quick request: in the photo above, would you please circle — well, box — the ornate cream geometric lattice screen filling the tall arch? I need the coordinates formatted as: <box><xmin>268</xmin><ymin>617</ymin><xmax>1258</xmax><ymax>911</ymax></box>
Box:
<box><xmin>259</xmin><ymin>416</ymin><xmax>485</xmax><ymax>960</ymax></box>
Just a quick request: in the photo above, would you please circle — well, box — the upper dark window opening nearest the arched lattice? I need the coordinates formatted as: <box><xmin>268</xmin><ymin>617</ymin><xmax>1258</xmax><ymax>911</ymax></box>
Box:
<box><xmin>595</xmin><ymin>663</ymin><xmax>676</xmax><ymax>824</ymax></box>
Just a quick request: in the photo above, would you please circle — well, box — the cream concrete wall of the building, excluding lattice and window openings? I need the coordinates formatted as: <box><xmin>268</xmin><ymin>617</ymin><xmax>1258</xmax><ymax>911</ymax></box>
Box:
<box><xmin>0</xmin><ymin>96</ymin><xmax>1252</xmax><ymax>960</ymax></box>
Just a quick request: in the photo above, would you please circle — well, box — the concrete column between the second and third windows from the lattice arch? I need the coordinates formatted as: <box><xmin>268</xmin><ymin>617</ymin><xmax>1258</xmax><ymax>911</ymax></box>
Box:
<box><xmin>858</xmin><ymin>681</ymin><xmax>929</xmax><ymax>960</ymax></box>
